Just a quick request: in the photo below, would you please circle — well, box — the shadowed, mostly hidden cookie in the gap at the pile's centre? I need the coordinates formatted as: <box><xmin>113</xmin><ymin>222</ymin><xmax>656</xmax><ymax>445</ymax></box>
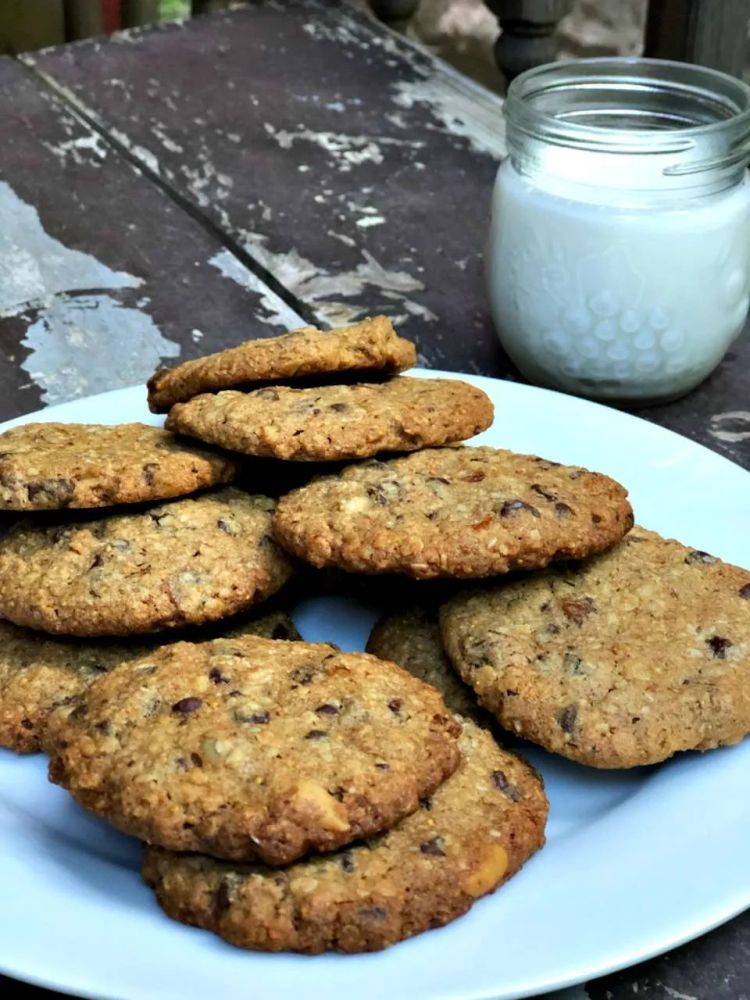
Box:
<box><xmin>367</xmin><ymin>605</ymin><xmax>494</xmax><ymax>726</ymax></box>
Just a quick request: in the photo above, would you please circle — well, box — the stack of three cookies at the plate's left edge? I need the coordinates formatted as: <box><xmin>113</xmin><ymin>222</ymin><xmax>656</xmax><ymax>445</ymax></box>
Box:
<box><xmin>0</xmin><ymin>423</ymin><xmax>300</xmax><ymax>752</ymax></box>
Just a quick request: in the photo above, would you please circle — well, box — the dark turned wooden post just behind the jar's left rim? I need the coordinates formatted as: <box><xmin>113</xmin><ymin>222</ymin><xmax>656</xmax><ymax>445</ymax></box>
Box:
<box><xmin>485</xmin><ymin>0</ymin><xmax>573</xmax><ymax>80</ymax></box>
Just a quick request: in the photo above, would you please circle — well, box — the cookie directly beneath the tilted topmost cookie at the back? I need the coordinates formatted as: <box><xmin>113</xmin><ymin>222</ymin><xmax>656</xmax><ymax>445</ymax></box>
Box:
<box><xmin>167</xmin><ymin>376</ymin><xmax>493</xmax><ymax>462</ymax></box>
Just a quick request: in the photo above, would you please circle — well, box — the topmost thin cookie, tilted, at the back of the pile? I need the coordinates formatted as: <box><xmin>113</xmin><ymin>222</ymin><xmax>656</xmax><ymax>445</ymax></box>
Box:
<box><xmin>148</xmin><ymin>316</ymin><xmax>417</xmax><ymax>413</ymax></box>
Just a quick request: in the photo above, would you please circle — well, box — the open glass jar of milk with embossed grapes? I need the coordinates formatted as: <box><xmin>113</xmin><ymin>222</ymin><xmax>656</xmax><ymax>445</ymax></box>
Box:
<box><xmin>487</xmin><ymin>59</ymin><xmax>750</xmax><ymax>403</ymax></box>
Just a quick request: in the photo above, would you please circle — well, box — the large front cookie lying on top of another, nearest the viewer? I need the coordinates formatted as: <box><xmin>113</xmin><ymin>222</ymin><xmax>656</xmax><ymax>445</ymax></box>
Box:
<box><xmin>50</xmin><ymin>636</ymin><xmax>460</xmax><ymax>865</ymax></box>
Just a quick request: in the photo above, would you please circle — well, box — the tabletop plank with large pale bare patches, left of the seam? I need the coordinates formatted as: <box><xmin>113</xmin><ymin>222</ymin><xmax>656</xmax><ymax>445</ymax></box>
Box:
<box><xmin>0</xmin><ymin>58</ymin><xmax>302</xmax><ymax>419</ymax></box>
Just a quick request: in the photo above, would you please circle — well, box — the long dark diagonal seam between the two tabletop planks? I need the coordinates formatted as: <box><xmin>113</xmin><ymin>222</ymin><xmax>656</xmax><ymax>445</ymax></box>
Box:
<box><xmin>16</xmin><ymin>55</ymin><xmax>324</xmax><ymax>326</ymax></box>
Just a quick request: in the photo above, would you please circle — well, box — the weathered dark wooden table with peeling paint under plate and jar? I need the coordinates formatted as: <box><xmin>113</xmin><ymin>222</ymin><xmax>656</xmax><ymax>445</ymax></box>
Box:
<box><xmin>0</xmin><ymin>0</ymin><xmax>750</xmax><ymax>1000</ymax></box>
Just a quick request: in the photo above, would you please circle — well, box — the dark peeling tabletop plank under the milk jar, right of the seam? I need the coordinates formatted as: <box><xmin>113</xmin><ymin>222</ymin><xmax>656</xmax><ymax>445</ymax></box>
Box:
<box><xmin>26</xmin><ymin>0</ymin><xmax>750</xmax><ymax>466</ymax></box>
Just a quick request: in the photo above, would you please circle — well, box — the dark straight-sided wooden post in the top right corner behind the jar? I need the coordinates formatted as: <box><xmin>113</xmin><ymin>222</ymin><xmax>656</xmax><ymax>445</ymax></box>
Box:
<box><xmin>646</xmin><ymin>0</ymin><xmax>750</xmax><ymax>76</ymax></box>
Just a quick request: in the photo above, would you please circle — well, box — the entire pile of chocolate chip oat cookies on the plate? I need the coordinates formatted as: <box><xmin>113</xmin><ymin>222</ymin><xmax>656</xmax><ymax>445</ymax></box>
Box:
<box><xmin>0</xmin><ymin>317</ymin><xmax>750</xmax><ymax>952</ymax></box>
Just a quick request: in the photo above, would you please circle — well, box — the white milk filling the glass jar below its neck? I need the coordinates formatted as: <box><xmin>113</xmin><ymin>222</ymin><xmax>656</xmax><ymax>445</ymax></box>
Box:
<box><xmin>486</xmin><ymin>159</ymin><xmax>750</xmax><ymax>402</ymax></box>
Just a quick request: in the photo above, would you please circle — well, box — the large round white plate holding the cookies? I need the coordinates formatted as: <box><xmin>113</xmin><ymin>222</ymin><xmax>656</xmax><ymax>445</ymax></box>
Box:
<box><xmin>0</xmin><ymin>372</ymin><xmax>750</xmax><ymax>1000</ymax></box>
